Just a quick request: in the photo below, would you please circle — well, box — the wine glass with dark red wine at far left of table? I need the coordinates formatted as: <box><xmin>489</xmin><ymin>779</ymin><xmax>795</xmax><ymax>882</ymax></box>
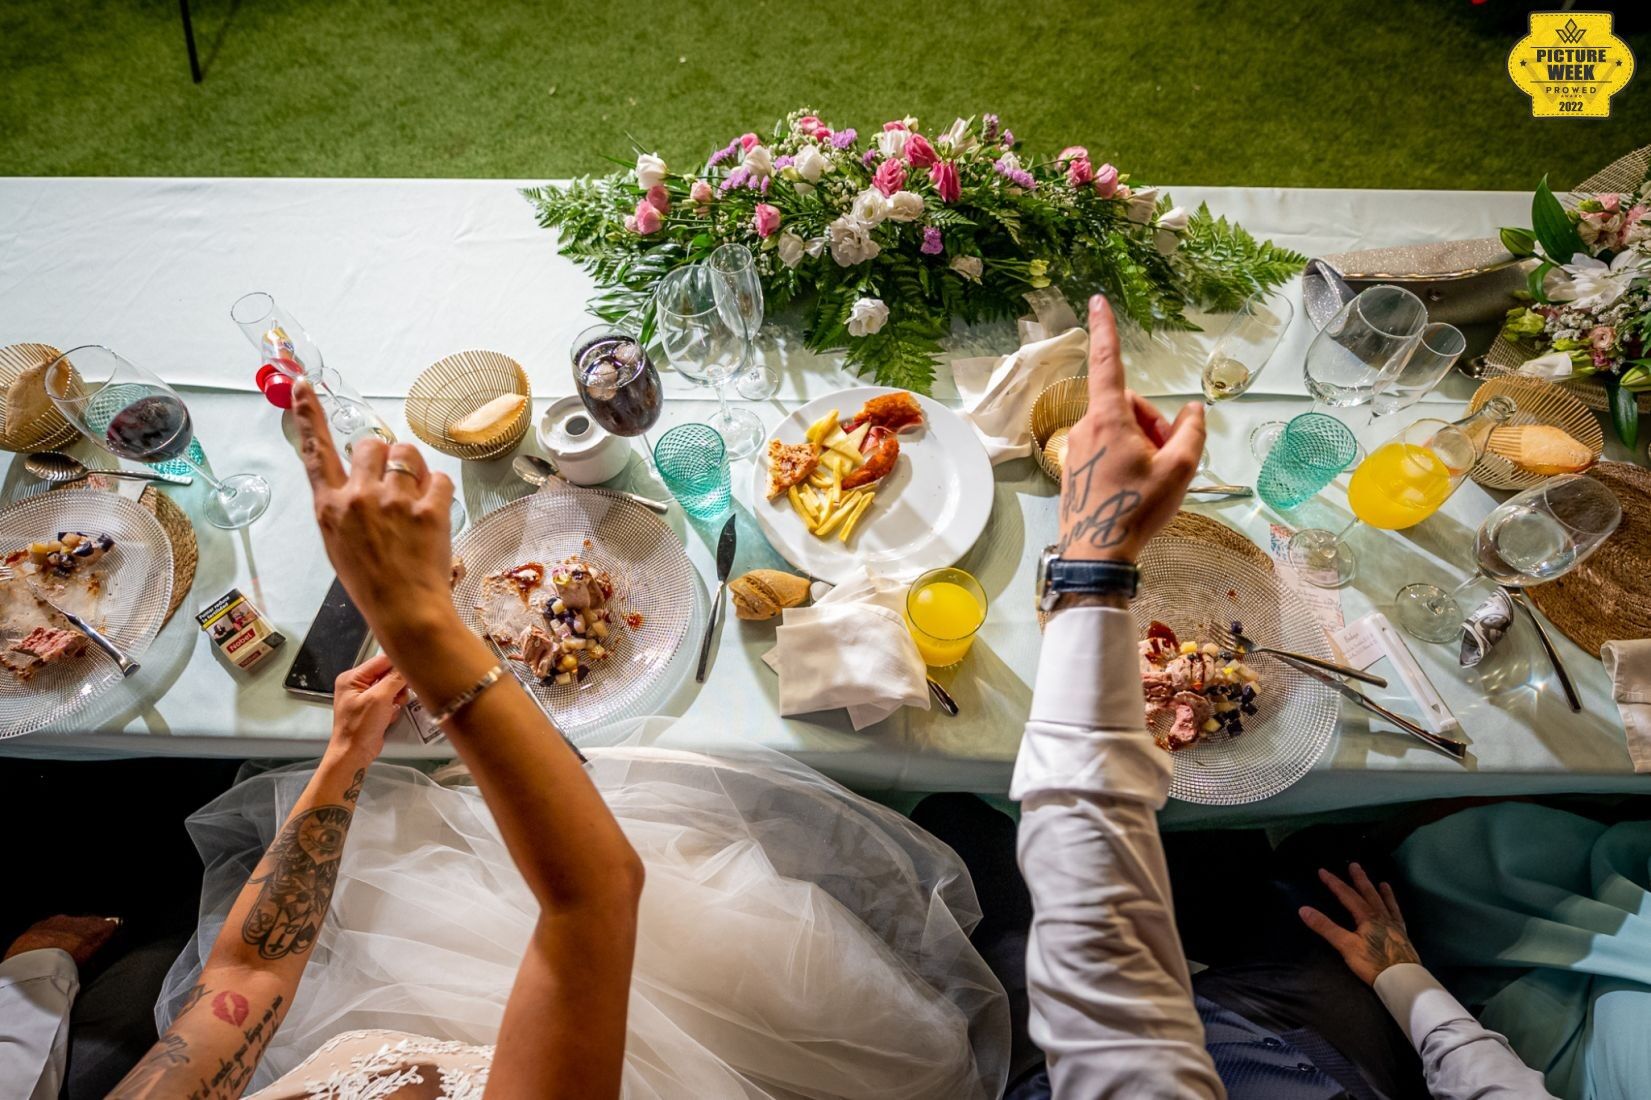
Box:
<box><xmin>46</xmin><ymin>344</ymin><xmax>269</xmax><ymax>529</ymax></box>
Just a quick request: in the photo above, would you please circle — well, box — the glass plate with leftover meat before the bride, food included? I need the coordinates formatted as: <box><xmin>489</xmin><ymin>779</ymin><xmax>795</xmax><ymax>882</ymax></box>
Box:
<box><xmin>452</xmin><ymin>486</ymin><xmax>705</xmax><ymax>745</ymax></box>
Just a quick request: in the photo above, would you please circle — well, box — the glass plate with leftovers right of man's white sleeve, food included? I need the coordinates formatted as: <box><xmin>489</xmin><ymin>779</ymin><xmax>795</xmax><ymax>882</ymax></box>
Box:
<box><xmin>1131</xmin><ymin>535</ymin><xmax>1341</xmax><ymax>806</ymax></box>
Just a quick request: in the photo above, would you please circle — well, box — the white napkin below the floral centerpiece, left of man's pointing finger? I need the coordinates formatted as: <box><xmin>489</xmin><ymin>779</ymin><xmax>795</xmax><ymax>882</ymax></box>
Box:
<box><xmin>951</xmin><ymin>291</ymin><xmax>1090</xmax><ymax>466</ymax></box>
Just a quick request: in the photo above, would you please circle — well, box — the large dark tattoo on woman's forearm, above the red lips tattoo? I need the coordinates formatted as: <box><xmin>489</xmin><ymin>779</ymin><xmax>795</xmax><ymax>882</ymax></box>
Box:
<box><xmin>241</xmin><ymin>806</ymin><xmax>350</xmax><ymax>960</ymax></box>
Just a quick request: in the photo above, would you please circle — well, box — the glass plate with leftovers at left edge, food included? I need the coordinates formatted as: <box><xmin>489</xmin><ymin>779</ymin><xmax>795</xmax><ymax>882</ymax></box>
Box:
<box><xmin>0</xmin><ymin>492</ymin><xmax>172</xmax><ymax>738</ymax></box>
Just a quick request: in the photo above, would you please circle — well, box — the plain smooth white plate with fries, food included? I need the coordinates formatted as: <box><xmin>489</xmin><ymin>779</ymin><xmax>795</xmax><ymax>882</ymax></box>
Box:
<box><xmin>751</xmin><ymin>386</ymin><xmax>994</xmax><ymax>585</ymax></box>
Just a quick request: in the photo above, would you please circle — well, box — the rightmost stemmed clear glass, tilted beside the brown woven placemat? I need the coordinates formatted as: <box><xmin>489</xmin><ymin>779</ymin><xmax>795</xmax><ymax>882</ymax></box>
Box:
<box><xmin>1395</xmin><ymin>474</ymin><xmax>1623</xmax><ymax>642</ymax></box>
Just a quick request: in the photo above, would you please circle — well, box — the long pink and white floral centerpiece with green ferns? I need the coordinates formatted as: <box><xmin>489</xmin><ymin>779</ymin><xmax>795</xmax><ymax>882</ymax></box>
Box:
<box><xmin>523</xmin><ymin>109</ymin><xmax>1306</xmax><ymax>391</ymax></box>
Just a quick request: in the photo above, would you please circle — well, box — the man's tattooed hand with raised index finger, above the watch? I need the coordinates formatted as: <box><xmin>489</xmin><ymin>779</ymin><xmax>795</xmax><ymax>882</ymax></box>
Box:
<box><xmin>1060</xmin><ymin>294</ymin><xmax>1204</xmax><ymax>562</ymax></box>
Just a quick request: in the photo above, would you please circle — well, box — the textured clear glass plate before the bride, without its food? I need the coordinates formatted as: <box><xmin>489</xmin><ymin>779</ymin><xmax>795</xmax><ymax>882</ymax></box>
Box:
<box><xmin>452</xmin><ymin>489</ymin><xmax>705</xmax><ymax>745</ymax></box>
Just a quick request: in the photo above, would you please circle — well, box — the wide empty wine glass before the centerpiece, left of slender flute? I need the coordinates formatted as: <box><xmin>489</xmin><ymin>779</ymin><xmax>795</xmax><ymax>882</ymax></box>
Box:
<box><xmin>654</xmin><ymin>264</ymin><xmax>764</xmax><ymax>459</ymax></box>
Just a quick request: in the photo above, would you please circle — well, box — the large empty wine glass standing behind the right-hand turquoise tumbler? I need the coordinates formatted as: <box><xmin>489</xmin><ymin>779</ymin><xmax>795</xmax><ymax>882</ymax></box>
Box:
<box><xmin>1250</xmin><ymin>286</ymin><xmax>1428</xmax><ymax>459</ymax></box>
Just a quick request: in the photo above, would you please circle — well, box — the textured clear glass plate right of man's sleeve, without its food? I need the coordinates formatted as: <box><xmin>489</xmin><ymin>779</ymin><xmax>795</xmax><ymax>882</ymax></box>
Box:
<box><xmin>1131</xmin><ymin>537</ymin><xmax>1341</xmax><ymax>806</ymax></box>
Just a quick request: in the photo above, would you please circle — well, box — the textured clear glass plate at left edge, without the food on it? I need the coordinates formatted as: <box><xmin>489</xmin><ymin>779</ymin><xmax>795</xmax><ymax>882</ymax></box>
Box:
<box><xmin>0</xmin><ymin>492</ymin><xmax>172</xmax><ymax>738</ymax></box>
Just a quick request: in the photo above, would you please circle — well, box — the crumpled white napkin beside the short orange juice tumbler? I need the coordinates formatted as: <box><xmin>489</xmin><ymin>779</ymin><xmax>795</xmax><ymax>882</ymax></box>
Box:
<box><xmin>763</xmin><ymin>573</ymin><xmax>930</xmax><ymax>730</ymax></box>
